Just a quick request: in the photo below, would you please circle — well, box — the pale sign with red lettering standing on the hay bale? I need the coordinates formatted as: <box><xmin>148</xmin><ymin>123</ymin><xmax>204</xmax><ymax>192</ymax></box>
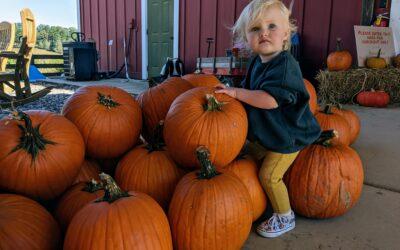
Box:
<box><xmin>354</xmin><ymin>26</ymin><xmax>396</xmax><ymax>67</ymax></box>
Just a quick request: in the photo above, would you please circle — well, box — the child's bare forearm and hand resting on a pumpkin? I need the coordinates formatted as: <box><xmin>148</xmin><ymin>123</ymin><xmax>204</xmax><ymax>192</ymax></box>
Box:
<box><xmin>215</xmin><ymin>84</ymin><xmax>278</xmax><ymax>109</ymax></box>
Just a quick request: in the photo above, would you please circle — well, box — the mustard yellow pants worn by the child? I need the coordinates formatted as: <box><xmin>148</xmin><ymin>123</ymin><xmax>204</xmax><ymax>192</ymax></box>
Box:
<box><xmin>246</xmin><ymin>142</ymin><xmax>299</xmax><ymax>214</ymax></box>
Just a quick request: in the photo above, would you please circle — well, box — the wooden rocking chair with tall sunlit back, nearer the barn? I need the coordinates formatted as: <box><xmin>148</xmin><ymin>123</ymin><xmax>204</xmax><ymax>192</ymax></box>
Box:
<box><xmin>0</xmin><ymin>9</ymin><xmax>51</xmax><ymax>108</ymax></box>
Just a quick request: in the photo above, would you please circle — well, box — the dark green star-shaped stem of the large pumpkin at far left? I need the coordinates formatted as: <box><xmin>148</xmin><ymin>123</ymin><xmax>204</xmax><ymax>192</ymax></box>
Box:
<box><xmin>11</xmin><ymin>110</ymin><xmax>56</xmax><ymax>159</ymax></box>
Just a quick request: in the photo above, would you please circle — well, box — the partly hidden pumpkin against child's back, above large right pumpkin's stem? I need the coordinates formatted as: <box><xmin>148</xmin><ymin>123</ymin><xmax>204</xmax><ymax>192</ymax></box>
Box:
<box><xmin>315</xmin><ymin>105</ymin><xmax>351</xmax><ymax>145</ymax></box>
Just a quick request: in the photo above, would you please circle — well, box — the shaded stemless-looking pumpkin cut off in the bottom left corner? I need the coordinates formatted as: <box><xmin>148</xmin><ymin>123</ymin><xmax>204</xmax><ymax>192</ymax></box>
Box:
<box><xmin>0</xmin><ymin>194</ymin><xmax>60</xmax><ymax>250</ymax></box>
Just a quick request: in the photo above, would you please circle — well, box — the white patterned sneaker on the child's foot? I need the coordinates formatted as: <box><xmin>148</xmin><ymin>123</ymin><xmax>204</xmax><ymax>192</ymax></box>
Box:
<box><xmin>257</xmin><ymin>211</ymin><xmax>296</xmax><ymax>238</ymax></box>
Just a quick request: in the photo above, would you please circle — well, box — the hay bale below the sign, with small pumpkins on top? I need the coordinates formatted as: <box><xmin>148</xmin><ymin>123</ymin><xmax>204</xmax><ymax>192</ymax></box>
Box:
<box><xmin>316</xmin><ymin>67</ymin><xmax>400</xmax><ymax>104</ymax></box>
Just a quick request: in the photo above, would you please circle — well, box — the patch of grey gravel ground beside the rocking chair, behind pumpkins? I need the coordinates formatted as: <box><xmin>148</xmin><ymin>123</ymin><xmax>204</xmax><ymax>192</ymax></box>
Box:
<box><xmin>0</xmin><ymin>83</ymin><xmax>79</xmax><ymax>119</ymax></box>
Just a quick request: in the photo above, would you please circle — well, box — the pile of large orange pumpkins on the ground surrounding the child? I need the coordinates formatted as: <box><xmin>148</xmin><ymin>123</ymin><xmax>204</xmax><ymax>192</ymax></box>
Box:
<box><xmin>0</xmin><ymin>74</ymin><xmax>363</xmax><ymax>249</ymax></box>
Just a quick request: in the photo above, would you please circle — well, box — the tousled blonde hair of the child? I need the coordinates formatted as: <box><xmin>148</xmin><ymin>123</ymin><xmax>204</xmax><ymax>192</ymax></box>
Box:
<box><xmin>232</xmin><ymin>0</ymin><xmax>297</xmax><ymax>50</ymax></box>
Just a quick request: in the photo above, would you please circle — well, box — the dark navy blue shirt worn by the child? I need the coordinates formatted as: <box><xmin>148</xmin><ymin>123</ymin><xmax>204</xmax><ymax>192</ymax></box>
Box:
<box><xmin>242</xmin><ymin>51</ymin><xmax>321</xmax><ymax>153</ymax></box>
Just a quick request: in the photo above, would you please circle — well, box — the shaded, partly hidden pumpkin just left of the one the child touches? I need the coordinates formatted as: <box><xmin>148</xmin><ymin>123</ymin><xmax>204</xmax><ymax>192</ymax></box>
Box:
<box><xmin>137</xmin><ymin>77</ymin><xmax>192</xmax><ymax>138</ymax></box>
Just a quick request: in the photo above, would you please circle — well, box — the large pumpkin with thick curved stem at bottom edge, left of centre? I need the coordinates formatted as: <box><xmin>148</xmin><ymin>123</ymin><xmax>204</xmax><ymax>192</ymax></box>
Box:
<box><xmin>64</xmin><ymin>174</ymin><xmax>172</xmax><ymax>250</ymax></box>
